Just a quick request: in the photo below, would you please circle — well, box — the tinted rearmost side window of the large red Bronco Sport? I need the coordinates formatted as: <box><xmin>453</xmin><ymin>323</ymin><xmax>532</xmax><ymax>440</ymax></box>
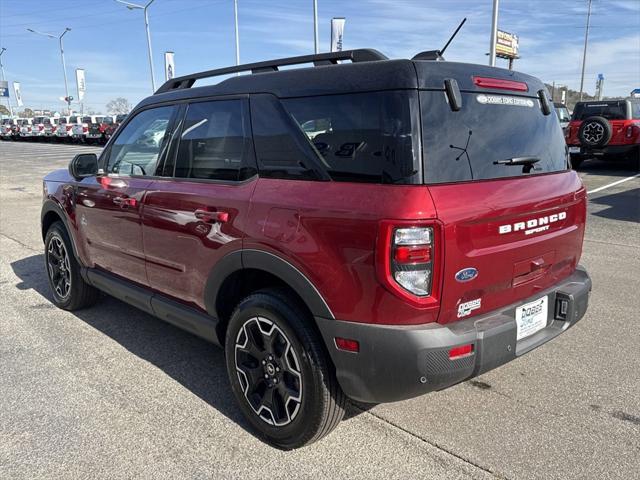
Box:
<box><xmin>282</xmin><ymin>91</ymin><xmax>421</xmax><ymax>184</ymax></box>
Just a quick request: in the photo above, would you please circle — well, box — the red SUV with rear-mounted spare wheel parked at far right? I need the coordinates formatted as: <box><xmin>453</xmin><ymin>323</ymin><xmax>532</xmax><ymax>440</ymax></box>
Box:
<box><xmin>565</xmin><ymin>98</ymin><xmax>640</xmax><ymax>168</ymax></box>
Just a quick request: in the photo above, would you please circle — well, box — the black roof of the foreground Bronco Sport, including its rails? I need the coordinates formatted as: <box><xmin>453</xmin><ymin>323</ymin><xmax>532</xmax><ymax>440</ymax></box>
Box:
<box><xmin>136</xmin><ymin>49</ymin><xmax>545</xmax><ymax>109</ymax></box>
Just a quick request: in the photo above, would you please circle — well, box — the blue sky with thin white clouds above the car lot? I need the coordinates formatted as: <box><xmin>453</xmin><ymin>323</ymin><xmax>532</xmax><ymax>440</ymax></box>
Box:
<box><xmin>0</xmin><ymin>0</ymin><xmax>640</xmax><ymax>112</ymax></box>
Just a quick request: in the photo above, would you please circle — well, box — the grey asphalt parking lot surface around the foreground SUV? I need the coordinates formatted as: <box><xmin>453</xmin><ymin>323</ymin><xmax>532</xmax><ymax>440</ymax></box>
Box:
<box><xmin>0</xmin><ymin>142</ymin><xmax>640</xmax><ymax>480</ymax></box>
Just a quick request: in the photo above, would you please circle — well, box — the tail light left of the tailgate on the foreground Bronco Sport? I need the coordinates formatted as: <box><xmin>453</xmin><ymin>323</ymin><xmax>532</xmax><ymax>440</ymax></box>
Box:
<box><xmin>376</xmin><ymin>221</ymin><xmax>440</xmax><ymax>306</ymax></box>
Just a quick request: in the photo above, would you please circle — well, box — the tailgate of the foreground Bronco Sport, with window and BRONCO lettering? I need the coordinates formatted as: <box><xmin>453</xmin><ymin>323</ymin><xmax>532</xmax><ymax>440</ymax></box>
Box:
<box><xmin>416</xmin><ymin>62</ymin><xmax>586</xmax><ymax>323</ymax></box>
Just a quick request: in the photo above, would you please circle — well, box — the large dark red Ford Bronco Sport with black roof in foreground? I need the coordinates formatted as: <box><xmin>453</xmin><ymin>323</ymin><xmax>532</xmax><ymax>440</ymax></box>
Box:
<box><xmin>42</xmin><ymin>50</ymin><xmax>591</xmax><ymax>448</ymax></box>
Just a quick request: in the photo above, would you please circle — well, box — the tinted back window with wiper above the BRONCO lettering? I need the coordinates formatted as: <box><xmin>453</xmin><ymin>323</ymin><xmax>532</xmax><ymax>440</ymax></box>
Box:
<box><xmin>420</xmin><ymin>91</ymin><xmax>567</xmax><ymax>183</ymax></box>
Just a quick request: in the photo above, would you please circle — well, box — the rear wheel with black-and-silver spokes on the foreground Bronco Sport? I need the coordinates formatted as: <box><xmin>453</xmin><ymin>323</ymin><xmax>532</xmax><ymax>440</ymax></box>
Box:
<box><xmin>225</xmin><ymin>289</ymin><xmax>346</xmax><ymax>450</ymax></box>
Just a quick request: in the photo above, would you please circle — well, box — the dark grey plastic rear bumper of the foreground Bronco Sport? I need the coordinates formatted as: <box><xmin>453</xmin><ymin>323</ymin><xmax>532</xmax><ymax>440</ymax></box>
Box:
<box><xmin>316</xmin><ymin>267</ymin><xmax>591</xmax><ymax>403</ymax></box>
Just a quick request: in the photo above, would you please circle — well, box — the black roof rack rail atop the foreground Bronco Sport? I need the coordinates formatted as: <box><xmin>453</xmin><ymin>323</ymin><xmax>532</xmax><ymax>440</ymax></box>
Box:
<box><xmin>155</xmin><ymin>48</ymin><xmax>388</xmax><ymax>94</ymax></box>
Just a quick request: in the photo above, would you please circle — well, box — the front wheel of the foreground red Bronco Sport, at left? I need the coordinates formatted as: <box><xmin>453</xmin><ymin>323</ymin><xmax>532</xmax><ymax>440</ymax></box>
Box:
<box><xmin>44</xmin><ymin>222</ymin><xmax>100</xmax><ymax>311</ymax></box>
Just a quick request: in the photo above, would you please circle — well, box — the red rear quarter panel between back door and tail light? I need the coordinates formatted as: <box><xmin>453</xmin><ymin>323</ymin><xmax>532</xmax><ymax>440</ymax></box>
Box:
<box><xmin>244</xmin><ymin>178</ymin><xmax>437</xmax><ymax>324</ymax></box>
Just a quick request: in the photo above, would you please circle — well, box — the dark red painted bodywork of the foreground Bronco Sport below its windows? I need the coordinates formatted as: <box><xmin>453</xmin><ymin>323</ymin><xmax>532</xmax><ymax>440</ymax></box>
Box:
<box><xmin>45</xmin><ymin>162</ymin><xmax>586</xmax><ymax>325</ymax></box>
